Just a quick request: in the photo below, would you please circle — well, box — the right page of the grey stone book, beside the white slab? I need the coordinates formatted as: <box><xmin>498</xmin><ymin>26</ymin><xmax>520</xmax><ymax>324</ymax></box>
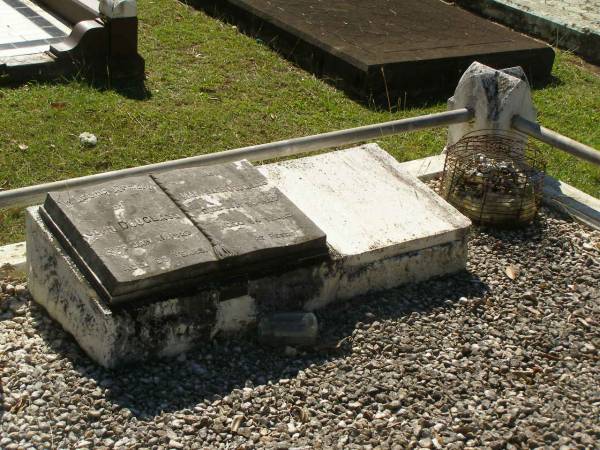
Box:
<box><xmin>154</xmin><ymin>160</ymin><xmax>326</xmax><ymax>266</ymax></box>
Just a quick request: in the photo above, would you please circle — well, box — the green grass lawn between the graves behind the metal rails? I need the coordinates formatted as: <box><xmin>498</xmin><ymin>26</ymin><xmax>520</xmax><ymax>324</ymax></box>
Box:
<box><xmin>0</xmin><ymin>0</ymin><xmax>600</xmax><ymax>244</ymax></box>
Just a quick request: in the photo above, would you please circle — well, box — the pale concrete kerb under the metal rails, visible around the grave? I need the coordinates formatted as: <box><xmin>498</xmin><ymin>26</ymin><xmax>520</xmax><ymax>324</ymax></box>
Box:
<box><xmin>0</xmin><ymin>154</ymin><xmax>600</xmax><ymax>274</ymax></box>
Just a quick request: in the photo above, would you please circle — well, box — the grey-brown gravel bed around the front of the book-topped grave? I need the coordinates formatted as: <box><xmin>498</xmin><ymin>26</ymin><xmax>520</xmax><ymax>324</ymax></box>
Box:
<box><xmin>0</xmin><ymin>210</ymin><xmax>600</xmax><ymax>450</ymax></box>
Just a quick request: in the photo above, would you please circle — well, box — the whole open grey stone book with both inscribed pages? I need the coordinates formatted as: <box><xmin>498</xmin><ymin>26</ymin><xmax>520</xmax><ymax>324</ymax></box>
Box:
<box><xmin>40</xmin><ymin>161</ymin><xmax>328</xmax><ymax>304</ymax></box>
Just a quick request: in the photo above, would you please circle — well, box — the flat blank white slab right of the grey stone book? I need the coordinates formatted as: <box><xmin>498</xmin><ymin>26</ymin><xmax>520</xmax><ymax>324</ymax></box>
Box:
<box><xmin>259</xmin><ymin>144</ymin><xmax>471</xmax><ymax>264</ymax></box>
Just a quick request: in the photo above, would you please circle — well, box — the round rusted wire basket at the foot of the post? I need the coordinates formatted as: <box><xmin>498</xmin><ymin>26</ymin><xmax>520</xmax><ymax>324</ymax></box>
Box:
<box><xmin>442</xmin><ymin>132</ymin><xmax>546</xmax><ymax>227</ymax></box>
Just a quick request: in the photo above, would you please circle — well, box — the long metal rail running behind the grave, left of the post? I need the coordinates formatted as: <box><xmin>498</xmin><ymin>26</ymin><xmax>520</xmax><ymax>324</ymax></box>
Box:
<box><xmin>0</xmin><ymin>108</ymin><xmax>474</xmax><ymax>208</ymax></box>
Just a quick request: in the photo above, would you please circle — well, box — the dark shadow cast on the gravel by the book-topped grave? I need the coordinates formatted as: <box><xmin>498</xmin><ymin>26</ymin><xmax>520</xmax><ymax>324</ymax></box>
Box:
<box><xmin>32</xmin><ymin>271</ymin><xmax>488</xmax><ymax>420</ymax></box>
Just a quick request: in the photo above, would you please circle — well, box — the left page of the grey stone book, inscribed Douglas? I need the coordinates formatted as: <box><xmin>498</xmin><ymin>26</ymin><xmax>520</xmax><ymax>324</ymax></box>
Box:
<box><xmin>44</xmin><ymin>176</ymin><xmax>217</xmax><ymax>303</ymax></box>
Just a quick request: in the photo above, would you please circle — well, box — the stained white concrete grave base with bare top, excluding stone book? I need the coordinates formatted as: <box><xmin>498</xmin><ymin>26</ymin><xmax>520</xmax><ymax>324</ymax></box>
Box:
<box><xmin>27</xmin><ymin>145</ymin><xmax>470</xmax><ymax>367</ymax></box>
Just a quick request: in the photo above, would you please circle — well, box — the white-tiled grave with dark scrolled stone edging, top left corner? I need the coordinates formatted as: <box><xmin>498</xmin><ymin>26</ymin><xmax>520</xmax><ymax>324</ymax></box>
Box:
<box><xmin>0</xmin><ymin>0</ymin><xmax>144</xmax><ymax>82</ymax></box>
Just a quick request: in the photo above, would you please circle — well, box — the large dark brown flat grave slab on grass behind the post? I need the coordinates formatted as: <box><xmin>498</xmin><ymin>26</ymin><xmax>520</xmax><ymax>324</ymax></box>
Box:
<box><xmin>203</xmin><ymin>0</ymin><xmax>554</xmax><ymax>103</ymax></box>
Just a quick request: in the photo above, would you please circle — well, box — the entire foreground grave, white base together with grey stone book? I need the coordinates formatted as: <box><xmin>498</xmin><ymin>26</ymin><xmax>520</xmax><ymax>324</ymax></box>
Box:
<box><xmin>27</xmin><ymin>144</ymin><xmax>470</xmax><ymax>367</ymax></box>
